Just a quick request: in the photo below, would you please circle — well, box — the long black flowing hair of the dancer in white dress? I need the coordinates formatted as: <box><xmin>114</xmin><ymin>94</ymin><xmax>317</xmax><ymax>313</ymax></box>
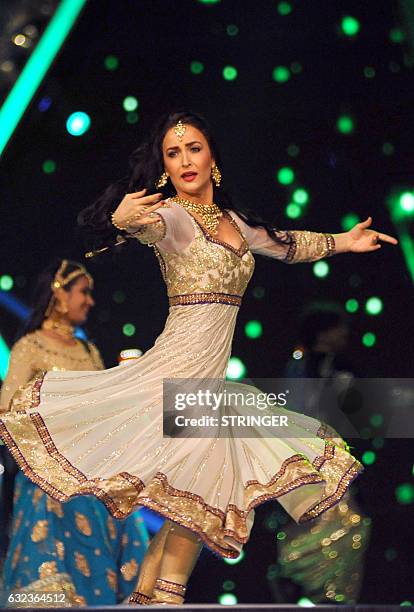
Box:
<box><xmin>78</xmin><ymin>111</ymin><xmax>291</xmax><ymax>250</ymax></box>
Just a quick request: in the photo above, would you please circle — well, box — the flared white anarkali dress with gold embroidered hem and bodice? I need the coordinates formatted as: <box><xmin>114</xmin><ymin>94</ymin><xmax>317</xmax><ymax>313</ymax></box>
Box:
<box><xmin>0</xmin><ymin>200</ymin><xmax>362</xmax><ymax>558</ymax></box>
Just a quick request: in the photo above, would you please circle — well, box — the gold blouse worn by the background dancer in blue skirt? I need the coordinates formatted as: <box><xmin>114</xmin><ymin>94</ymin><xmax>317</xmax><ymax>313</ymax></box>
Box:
<box><xmin>0</xmin><ymin>330</ymin><xmax>104</xmax><ymax>410</ymax></box>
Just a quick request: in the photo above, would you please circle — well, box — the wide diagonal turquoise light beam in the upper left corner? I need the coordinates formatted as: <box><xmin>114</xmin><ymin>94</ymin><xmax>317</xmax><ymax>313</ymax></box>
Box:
<box><xmin>0</xmin><ymin>0</ymin><xmax>86</xmax><ymax>155</ymax></box>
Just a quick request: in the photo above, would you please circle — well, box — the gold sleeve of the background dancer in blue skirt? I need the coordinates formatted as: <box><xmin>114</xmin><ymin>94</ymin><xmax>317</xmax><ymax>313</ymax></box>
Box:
<box><xmin>0</xmin><ymin>336</ymin><xmax>37</xmax><ymax>410</ymax></box>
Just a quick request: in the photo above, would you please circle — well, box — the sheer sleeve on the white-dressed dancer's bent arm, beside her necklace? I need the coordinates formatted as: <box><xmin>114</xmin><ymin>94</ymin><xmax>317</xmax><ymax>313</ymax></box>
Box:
<box><xmin>132</xmin><ymin>201</ymin><xmax>194</xmax><ymax>252</ymax></box>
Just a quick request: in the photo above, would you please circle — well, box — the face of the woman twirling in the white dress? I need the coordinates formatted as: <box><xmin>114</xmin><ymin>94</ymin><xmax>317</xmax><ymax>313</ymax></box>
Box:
<box><xmin>162</xmin><ymin>124</ymin><xmax>214</xmax><ymax>197</ymax></box>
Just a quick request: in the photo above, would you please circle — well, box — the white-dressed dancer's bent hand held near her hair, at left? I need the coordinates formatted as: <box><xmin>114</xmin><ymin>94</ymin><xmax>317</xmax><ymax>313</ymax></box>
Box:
<box><xmin>112</xmin><ymin>189</ymin><xmax>165</xmax><ymax>232</ymax></box>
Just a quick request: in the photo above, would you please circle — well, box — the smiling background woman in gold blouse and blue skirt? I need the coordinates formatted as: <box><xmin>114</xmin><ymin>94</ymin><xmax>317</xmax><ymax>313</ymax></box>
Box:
<box><xmin>0</xmin><ymin>260</ymin><xmax>148</xmax><ymax>606</ymax></box>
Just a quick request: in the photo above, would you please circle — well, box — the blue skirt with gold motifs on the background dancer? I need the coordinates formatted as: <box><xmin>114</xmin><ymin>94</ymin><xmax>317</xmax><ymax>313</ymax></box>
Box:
<box><xmin>3</xmin><ymin>472</ymin><xmax>148</xmax><ymax>607</ymax></box>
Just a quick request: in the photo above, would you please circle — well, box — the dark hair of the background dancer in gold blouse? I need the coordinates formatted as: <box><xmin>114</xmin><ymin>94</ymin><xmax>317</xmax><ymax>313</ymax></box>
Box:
<box><xmin>15</xmin><ymin>257</ymin><xmax>92</xmax><ymax>342</ymax></box>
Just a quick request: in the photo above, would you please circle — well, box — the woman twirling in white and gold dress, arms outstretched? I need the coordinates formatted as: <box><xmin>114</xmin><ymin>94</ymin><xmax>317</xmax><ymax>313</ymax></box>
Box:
<box><xmin>0</xmin><ymin>113</ymin><xmax>397</xmax><ymax>603</ymax></box>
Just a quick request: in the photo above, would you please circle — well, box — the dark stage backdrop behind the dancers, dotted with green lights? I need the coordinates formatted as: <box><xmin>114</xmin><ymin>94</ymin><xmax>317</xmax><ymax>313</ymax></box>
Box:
<box><xmin>0</xmin><ymin>0</ymin><xmax>414</xmax><ymax>603</ymax></box>
